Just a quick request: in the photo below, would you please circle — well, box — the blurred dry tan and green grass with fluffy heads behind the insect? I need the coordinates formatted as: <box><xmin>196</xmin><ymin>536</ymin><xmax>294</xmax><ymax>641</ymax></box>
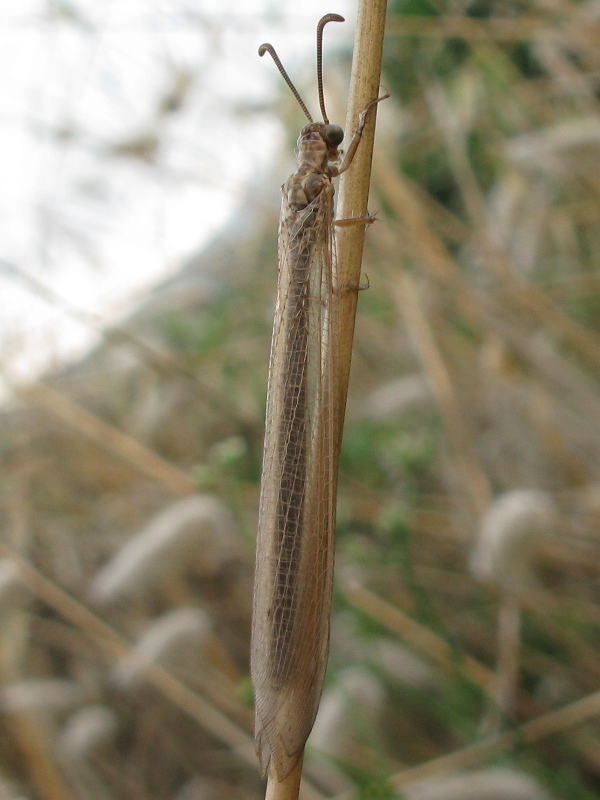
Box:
<box><xmin>0</xmin><ymin>0</ymin><xmax>600</xmax><ymax>800</ymax></box>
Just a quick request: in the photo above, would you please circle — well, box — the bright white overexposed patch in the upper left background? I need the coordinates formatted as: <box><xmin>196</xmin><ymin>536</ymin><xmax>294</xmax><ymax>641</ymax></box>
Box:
<box><xmin>0</xmin><ymin>0</ymin><xmax>355</xmax><ymax>388</ymax></box>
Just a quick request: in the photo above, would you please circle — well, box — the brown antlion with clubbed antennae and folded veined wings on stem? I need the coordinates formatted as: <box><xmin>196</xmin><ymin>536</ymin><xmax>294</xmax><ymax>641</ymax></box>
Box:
<box><xmin>251</xmin><ymin>14</ymin><xmax>388</xmax><ymax>781</ymax></box>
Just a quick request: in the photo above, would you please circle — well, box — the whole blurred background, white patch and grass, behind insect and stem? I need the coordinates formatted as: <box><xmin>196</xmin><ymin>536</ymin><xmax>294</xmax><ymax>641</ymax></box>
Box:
<box><xmin>0</xmin><ymin>0</ymin><xmax>600</xmax><ymax>800</ymax></box>
